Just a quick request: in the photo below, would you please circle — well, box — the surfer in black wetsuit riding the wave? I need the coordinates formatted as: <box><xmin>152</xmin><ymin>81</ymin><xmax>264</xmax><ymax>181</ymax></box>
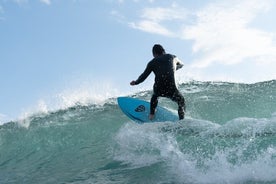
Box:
<box><xmin>130</xmin><ymin>44</ymin><xmax>186</xmax><ymax>120</ymax></box>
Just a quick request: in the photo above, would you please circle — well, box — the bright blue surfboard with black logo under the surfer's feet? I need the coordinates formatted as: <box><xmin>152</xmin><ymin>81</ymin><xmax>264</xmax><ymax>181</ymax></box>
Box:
<box><xmin>117</xmin><ymin>97</ymin><xmax>179</xmax><ymax>123</ymax></box>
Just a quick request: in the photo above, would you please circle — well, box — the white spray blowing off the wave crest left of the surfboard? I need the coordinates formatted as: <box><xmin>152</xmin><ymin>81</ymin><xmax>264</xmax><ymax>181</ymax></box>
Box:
<box><xmin>14</xmin><ymin>82</ymin><xmax>132</xmax><ymax>127</ymax></box>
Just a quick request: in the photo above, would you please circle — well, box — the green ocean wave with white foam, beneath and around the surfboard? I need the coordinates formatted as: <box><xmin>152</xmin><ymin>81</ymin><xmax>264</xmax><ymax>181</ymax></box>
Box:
<box><xmin>0</xmin><ymin>80</ymin><xmax>276</xmax><ymax>184</ymax></box>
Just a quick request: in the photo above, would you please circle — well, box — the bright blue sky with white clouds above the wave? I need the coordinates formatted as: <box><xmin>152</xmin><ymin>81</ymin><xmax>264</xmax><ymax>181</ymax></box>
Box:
<box><xmin>0</xmin><ymin>0</ymin><xmax>276</xmax><ymax>123</ymax></box>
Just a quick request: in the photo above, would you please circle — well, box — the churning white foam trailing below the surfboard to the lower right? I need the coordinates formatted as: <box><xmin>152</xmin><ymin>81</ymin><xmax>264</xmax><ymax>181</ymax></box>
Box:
<box><xmin>114</xmin><ymin>118</ymin><xmax>276</xmax><ymax>183</ymax></box>
